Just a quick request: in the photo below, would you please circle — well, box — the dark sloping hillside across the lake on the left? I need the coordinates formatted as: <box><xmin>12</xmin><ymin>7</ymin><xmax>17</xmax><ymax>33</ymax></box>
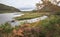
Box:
<box><xmin>0</xmin><ymin>4</ymin><xmax>20</xmax><ymax>12</ymax></box>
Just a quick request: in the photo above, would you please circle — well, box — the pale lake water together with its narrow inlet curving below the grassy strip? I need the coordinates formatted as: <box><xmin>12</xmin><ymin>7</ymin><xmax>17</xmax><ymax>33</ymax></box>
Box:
<box><xmin>0</xmin><ymin>13</ymin><xmax>47</xmax><ymax>26</ymax></box>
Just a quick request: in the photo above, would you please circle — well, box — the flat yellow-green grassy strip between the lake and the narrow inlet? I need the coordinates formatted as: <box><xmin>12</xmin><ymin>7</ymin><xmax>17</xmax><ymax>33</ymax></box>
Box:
<box><xmin>15</xmin><ymin>12</ymin><xmax>49</xmax><ymax>20</ymax></box>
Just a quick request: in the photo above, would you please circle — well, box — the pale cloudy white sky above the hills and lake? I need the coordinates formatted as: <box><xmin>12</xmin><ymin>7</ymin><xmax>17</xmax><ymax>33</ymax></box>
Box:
<box><xmin>0</xmin><ymin>0</ymin><xmax>40</xmax><ymax>9</ymax></box>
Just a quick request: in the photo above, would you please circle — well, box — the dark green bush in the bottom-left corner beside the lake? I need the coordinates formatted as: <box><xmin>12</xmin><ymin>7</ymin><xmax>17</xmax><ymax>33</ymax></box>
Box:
<box><xmin>0</xmin><ymin>23</ymin><xmax>13</xmax><ymax>37</ymax></box>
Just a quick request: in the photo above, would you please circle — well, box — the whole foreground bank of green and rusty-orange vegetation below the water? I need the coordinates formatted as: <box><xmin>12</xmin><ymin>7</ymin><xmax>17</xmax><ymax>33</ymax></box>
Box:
<box><xmin>0</xmin><ymin>15</ymin><xmax>60</xmax><ymax>37</ymax></box>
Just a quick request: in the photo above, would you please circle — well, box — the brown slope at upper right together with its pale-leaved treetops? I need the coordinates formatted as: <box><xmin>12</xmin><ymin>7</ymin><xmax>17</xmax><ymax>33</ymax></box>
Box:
<box><xmin>36</xmin><ymin>0</ymin><xmax>60</xmax><ymax>13</ymax></box>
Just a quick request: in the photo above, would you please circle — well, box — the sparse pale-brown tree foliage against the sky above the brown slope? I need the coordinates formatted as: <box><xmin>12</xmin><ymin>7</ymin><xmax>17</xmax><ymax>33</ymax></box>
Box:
<box><xmin>36</xmin><ymin>0</ymin><xmax>60</xmax><ymax>12</ymax></box>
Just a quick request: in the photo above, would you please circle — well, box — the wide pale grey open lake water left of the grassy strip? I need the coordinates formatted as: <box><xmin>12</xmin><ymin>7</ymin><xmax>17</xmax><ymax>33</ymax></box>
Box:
<box><xmin>0</xmin><ymin>13</ymin><xmax>23</xmax><ymax>24</ymax></box>
